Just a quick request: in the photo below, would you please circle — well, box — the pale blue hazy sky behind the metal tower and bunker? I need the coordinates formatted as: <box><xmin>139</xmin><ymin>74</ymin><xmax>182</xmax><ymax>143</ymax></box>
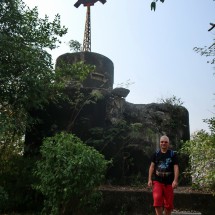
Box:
<box><xmin>24</xmin><ymin>0</ymin><xmax>215</xmax><ymax>134</ymax></box>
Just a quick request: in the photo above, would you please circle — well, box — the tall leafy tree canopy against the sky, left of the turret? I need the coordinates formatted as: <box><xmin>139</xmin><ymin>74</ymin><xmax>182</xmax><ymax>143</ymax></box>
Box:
<box><xmin>0</xmin><ymin>0</ymin><xmax>67</xmax><ymax>140</ymax></box>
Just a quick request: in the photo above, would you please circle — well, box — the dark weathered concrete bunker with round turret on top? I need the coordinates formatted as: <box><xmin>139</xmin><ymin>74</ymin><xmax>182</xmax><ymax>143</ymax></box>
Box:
<box><xmin>25</xmin><ymin>52</ymin><xmax>190</xmax><ymax>183</ymax></box>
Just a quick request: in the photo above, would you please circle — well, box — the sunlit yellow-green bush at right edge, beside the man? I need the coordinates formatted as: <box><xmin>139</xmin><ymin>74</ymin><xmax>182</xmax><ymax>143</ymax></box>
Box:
<box><xmin>181</xmin><ymin>126</ymin><xmax>215</xmax><ymax>192</ymax></box>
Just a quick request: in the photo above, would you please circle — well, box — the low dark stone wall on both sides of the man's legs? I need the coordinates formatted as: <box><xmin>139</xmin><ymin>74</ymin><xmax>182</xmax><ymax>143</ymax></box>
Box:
<box><xmin>99</xmin><ymin>188</ymin><xmax>215</xmax><ymax>215</ymax></box>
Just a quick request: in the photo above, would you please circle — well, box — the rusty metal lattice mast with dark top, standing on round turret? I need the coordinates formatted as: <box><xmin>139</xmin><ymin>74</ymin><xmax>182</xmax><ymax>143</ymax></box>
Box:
<box><xmin>74</xmin><ymin>0</ymin><xmax>106</xmax><ymax>52</ymax></box>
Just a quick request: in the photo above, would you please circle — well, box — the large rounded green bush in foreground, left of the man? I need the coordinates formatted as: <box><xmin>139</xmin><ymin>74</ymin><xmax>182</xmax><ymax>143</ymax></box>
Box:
<box><xmin>35</xmin><ymin>133</ymin><xmax>108</xmax><ymax>215</ymax></box>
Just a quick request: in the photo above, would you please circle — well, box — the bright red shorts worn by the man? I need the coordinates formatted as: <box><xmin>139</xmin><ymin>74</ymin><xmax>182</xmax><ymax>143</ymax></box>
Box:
<box><xmin>152</xmin><ymin>181</ymin><xmax>174</xmax><ymax>210</ymax></box>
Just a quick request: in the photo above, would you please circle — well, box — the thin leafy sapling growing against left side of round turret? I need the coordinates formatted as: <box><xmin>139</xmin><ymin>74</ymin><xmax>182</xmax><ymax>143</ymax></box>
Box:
<box><xmin>47</xmin><ymin>60</ymin><xmax>96</xmax><ymax>131</ymax></box>
